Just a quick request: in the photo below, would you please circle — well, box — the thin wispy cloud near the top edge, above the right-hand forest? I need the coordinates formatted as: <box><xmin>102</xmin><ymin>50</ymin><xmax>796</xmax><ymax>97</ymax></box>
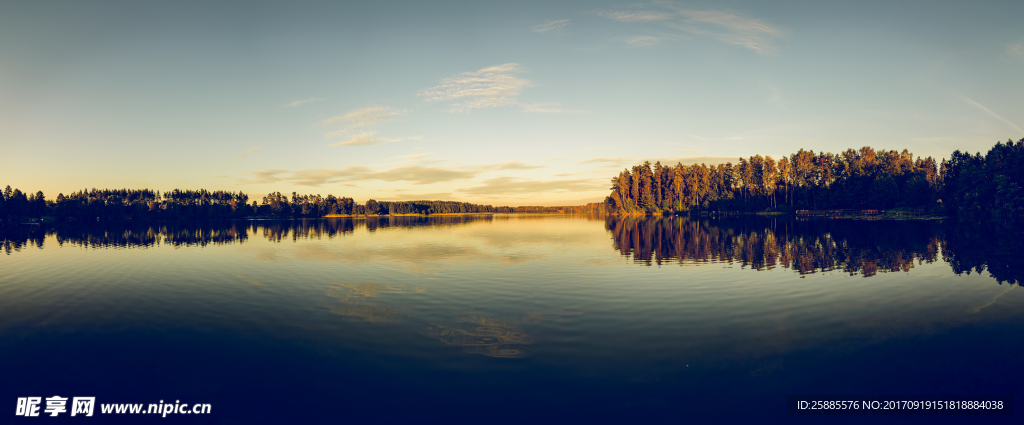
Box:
<box><xmin>597</xmin><ymin>3</ymin><xmax>785</xmax><ymax>54</ymax></box>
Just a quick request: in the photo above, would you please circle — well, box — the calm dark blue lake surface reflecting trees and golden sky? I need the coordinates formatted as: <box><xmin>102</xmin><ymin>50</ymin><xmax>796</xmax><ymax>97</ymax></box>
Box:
<box><xmin>0</xmin><ymin>215</ymin><xmax>1024</xmax><ymax>423</ymax></box>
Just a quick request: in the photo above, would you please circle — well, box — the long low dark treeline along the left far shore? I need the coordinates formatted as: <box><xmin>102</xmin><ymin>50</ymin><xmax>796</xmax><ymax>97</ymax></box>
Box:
<box><xmin>0</xmin><ymin>185</ymin><xmax>528</xmax><ymax>223</ymax></box>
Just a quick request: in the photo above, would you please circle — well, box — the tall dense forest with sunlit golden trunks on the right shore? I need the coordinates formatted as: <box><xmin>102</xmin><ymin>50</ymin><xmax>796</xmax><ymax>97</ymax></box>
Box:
<box><xmin>605</xmin><ymin>139</ymin><xmax>1024</xmax><ymax>215</ymax></box>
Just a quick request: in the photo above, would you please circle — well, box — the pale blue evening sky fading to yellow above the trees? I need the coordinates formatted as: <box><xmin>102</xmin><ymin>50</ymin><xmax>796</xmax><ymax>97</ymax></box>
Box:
<box><xmin>0</xmin><ymin>0</ymin><xmax>1024</xmax><ymax>206</ymax></box>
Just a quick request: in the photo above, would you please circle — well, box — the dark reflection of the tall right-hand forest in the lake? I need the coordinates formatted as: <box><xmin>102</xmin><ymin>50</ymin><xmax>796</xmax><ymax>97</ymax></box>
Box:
<box><xmin>605</xmin><ymin>216</ymin><xmax>1024</xmax><ymax>284</ymax></box>
